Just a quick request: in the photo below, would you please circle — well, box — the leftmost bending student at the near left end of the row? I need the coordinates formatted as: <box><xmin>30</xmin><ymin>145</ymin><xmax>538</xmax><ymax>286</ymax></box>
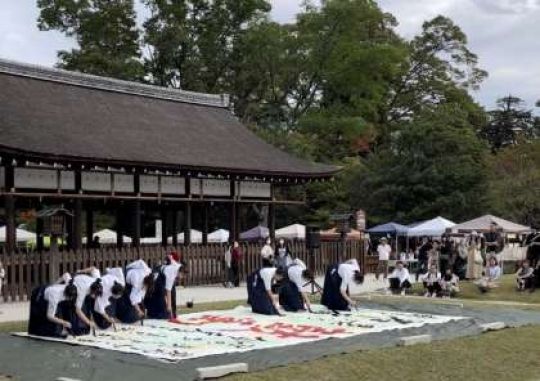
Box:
<box><xmin>28</xmin><ymin>279</ymin><xmax>77</xmax><ymax>338</ymax></box>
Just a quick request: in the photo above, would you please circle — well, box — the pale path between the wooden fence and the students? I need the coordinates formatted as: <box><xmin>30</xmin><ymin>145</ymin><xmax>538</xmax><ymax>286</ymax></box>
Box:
<box><xmin>0</xmin><ymin>274</ymin><xmax>387</xmax><ymax>323</ymax></box>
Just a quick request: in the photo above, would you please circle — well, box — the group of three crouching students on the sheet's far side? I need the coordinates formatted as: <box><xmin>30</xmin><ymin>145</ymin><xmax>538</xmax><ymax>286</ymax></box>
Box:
<box><xmin>247</xmin><ymin>259</ymin><xmax>364</xmax><ymax>315</ymax></box>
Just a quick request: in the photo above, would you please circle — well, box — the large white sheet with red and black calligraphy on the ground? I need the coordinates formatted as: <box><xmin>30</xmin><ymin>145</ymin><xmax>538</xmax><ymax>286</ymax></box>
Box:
<box><xmin>17</xmin><ymin>306</ymin><xmax>462</xmax><ymax>362</ymax></box>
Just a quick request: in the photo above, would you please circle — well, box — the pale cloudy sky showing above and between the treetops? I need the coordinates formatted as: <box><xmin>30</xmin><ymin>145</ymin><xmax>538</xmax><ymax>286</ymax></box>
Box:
<box><xmin>0</xmin><ymin>0</ymin><xmax>540</xmax><ymax>111</ymax></box>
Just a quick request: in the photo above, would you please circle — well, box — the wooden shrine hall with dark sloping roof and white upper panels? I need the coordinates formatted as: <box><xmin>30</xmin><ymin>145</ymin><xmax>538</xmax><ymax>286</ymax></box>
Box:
<box><xmin>0</xmin><ymin>60</ymin><xmax>338</xmax><ymax>253</ymax></box>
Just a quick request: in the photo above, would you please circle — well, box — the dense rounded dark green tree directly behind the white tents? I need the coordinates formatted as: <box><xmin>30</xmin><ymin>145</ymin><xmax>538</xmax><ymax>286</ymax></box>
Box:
<box><xmin>350</xmin><ymin>104</ymin><xmax>488</xmax><ymax>223</ymax></box>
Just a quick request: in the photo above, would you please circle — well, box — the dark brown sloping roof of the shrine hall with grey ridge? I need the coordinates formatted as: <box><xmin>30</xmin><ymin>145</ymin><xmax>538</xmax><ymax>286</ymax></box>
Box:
<box><xmin>0</xmin><ymin>60</ymin><xmax>338</xmax><ymax>178</ymax></box>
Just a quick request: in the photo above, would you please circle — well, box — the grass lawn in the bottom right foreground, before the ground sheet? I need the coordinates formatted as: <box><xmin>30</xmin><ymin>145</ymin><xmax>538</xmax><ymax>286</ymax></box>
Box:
<box><xmin>224</xmin><ymin>326</ymin><xmax>540</xmax><ymax>381</ymax></box>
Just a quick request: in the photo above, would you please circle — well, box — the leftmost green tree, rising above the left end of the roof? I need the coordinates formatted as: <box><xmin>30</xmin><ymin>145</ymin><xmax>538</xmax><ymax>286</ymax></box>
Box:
<box><xmin>37</xmin><ymin>0</ymin><xmax>144</xmax><ymax>80</ymax></box>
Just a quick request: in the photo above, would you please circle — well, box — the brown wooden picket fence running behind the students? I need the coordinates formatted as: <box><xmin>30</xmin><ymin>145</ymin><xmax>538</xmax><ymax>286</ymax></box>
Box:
<box><xmin>0</xmin><ymin>241</ymin><xmax>376</xmax><ymax>301</ymax></box>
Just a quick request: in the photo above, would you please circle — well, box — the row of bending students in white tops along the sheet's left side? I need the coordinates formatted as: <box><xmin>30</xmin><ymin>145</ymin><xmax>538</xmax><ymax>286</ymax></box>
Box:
<box><xmin>28</xmin><ymin>252</ymin><xmax>186</xmax><ymax>337</ymax></box>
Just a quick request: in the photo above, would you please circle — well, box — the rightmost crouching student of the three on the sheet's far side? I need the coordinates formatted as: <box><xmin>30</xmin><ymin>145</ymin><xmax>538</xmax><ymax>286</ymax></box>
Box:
<box><xmin>321</xmin><ymin>259</ymin><xmax>364</xmax><ymax>311</ymax></box>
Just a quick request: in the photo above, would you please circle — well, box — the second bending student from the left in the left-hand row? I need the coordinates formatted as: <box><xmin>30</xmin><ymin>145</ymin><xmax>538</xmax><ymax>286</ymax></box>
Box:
<box><xmin>71</xmin><ymin>267</ymin><xmax>103</xmax><ymax>336</ymax></box>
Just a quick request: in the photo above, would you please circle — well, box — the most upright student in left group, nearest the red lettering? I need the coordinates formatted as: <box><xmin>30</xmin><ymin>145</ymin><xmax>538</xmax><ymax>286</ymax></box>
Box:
<box><xmin>144</xmin><ymin>252</ymin><xmax>184</xmax><ymax>319</ymax></box>
